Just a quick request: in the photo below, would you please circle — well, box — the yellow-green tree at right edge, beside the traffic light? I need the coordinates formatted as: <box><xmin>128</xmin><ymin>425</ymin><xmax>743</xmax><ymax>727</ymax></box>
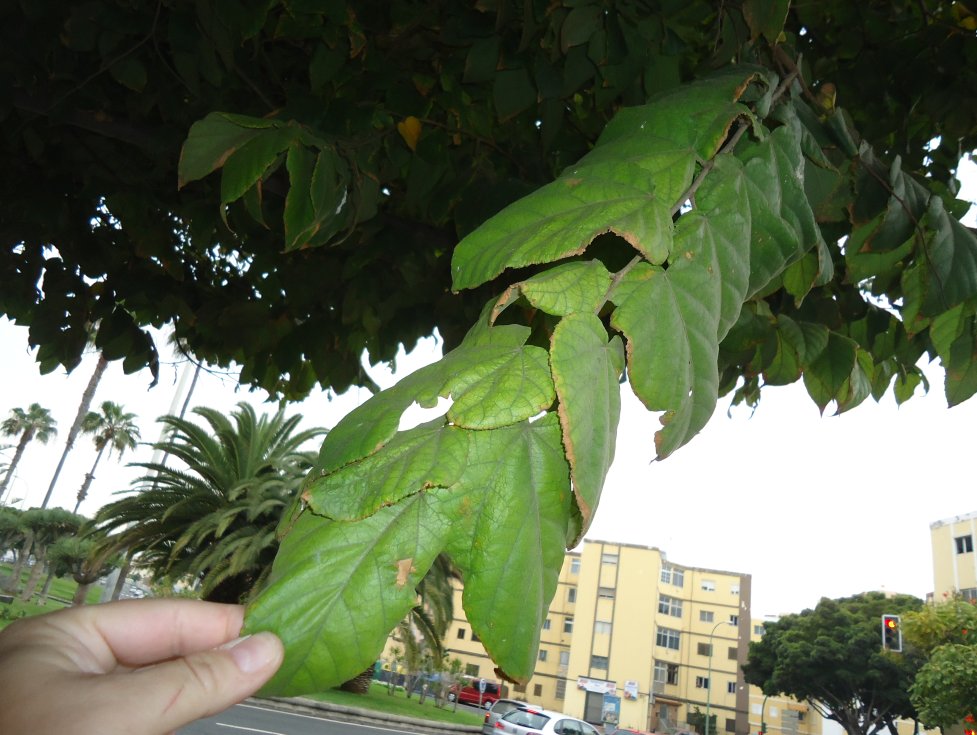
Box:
<box><xmin>902</xmin><ymin>596</ymin><xmax>977</xmax><ymax>731</ymax></box>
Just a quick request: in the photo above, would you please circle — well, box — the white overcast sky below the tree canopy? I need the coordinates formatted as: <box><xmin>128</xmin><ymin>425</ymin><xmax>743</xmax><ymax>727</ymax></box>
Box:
<box><xmin>0</xmin><ymin>157</ymin><xmax>977</xmax><ymax>617</ymax></box>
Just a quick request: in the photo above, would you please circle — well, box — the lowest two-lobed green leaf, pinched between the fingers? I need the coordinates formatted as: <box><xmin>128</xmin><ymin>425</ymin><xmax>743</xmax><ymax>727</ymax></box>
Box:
<box><xmin>246</xmin><ymin>414</ymin><xmax>572</xmax><ymax>694</ymax></box>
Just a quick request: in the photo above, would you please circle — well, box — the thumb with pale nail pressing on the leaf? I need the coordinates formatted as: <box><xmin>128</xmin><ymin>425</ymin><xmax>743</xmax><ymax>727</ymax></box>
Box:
<box><xmin>118</xmin><ymin>632</ymin><xmax>284</xmax><ymax>732</ymax></box>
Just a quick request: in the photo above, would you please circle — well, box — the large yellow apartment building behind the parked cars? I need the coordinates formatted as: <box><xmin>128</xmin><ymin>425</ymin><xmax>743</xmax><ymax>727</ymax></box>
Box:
<box><xmin>436</xmin><ymin>540</ymin><xmax>820</xmax><ymax>735</ymax></box>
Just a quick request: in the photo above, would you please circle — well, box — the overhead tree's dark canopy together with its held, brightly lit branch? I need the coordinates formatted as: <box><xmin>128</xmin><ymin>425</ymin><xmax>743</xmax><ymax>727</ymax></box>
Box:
<box><xmin>0</xmin><ymin>0</ymin><xmax>977</xmax><ymax>692</ymax></box>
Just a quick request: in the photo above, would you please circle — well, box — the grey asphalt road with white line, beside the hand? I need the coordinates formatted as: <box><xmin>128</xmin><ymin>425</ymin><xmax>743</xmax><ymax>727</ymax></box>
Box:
<box><xmin>177</xmin><ymin>704</ymin><xmax>424</xmax><ymax>735</ymax></box>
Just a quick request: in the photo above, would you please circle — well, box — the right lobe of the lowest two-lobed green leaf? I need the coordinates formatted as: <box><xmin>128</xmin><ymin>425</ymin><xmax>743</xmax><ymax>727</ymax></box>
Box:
<box><xmin>446</xmin><ymin>413</ymin><xmax>573</xmax><ymax>683</ymax></box>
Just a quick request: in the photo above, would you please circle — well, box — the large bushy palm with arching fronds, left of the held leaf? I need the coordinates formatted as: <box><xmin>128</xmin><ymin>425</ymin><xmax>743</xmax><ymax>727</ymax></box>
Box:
<box><xmin>95</xmin><ymin>403</ymin><xmax>325</xmax><ymax>602</ymax></box>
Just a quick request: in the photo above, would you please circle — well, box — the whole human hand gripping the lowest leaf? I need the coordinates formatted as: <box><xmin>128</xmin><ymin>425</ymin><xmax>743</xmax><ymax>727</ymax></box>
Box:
<box><xmin>0</xmin><ymin>599</ymin><xmax>283</xmax><ymax>735</ymax></box>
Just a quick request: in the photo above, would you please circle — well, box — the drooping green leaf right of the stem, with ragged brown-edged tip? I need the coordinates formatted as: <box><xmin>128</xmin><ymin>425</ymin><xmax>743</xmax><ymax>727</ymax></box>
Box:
<box><xmin>611</xmin><ymin>156</ymin><xmax>750</xmax><ymax>457</ymax></box>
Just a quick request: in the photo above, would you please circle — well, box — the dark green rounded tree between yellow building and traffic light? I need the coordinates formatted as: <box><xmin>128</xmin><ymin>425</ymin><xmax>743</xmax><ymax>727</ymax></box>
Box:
<box><xmin>743</xmin><ymin>592</ymin><xmax>923</xmax><ymax>735</ymax></box>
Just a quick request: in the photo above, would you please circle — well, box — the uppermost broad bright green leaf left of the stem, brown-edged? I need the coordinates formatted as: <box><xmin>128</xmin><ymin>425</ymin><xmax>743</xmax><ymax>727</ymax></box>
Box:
<box><xmin>452</xmin><ymin>69</ymin><xmax>769</xmax><ymax>289</ymax></box>
